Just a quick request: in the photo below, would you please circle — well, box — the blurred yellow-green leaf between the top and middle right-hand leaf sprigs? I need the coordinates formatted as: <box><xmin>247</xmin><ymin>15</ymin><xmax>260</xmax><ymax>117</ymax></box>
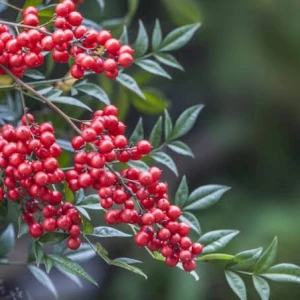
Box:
<box><xmin>131</xmin><ymin>88</ymin><xmax>169</xmax><ymax>115</ymax></box>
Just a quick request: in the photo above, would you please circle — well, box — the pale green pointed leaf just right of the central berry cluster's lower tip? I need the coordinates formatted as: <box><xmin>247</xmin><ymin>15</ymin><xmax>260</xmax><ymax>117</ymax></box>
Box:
<box><xmin>199</xmin><ymin>230</ymin><xmax>239</xmax><ymax>254</ymax></box>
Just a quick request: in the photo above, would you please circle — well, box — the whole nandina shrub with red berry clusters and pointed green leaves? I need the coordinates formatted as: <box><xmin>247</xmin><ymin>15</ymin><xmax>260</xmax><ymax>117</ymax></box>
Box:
<box><xmin>0</xmin><ymin>0</ymin><xmax>300</xmax><ymax>299</ymax></box>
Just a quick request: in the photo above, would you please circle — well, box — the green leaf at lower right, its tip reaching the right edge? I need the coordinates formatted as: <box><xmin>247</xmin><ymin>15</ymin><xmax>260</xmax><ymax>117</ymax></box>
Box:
<box><xmin>260</xmin><ymin>264</ymin><xmax>300</xmax><ymax>283</ymax></box>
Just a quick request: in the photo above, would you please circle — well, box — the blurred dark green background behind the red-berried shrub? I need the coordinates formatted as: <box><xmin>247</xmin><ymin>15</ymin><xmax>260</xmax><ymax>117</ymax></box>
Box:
<box><xmin>0</xmin><ymin>0</ymin><xmax>300</xmax><ymax>300</ymax></box>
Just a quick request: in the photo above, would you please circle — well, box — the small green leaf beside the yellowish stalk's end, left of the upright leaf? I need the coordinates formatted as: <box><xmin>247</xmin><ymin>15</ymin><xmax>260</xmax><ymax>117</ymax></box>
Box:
<box><xmin>230</xmin><ymin>248</ymin><xmax>262</xmax><ymax>271</ymax></box>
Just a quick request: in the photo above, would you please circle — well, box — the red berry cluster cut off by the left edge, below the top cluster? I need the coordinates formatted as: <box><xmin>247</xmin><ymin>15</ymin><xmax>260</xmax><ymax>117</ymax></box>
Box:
<box><xmin>0</xmin><ymin>114</ymin><xmax>81</xmax><ymax>250</ymax></box>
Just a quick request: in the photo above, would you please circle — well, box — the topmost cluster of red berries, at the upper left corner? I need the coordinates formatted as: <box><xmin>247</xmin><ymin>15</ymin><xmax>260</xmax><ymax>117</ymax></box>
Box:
<box><xmin>0</xmin><ymin>0</ymin><xmax>133</xmax><ymax>79</ymax></box>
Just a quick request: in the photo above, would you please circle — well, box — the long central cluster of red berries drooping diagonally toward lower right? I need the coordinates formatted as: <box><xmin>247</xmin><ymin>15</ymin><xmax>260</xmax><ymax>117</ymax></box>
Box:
<box><xmin>66</xmin><ymin>105</ymin><xmax>203</xmax><ymax>272</ymax></box>
